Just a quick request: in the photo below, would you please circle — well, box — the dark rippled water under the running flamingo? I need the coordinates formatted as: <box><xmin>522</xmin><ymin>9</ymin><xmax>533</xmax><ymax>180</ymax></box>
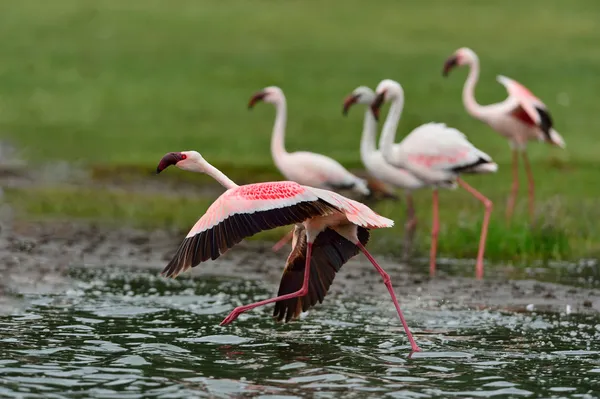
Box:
<box><xmin>0</xmin><ymin>268</ymin><xmax>600</xmax><ymax>398</ymax></box>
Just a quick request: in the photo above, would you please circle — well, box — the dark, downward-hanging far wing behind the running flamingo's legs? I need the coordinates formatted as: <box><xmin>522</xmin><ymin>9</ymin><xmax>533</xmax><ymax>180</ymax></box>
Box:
<box><xmin>273</xmin><ymin>225</ymin><xmax>369</xmax><ymax>323</ymax></box>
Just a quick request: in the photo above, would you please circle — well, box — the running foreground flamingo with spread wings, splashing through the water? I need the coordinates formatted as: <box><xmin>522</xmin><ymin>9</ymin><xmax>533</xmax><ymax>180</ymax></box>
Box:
<box><xmin>156</xmin><ymin>151</ymin><xmax>420</xmax><ymax>352</ymax></box>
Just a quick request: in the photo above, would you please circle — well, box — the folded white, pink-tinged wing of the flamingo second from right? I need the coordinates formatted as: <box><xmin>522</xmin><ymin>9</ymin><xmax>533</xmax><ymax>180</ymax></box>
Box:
<box><xmin>399</xmin><ymin>123</ymin><xmax>492</xmax><ymax>172</ymax></box>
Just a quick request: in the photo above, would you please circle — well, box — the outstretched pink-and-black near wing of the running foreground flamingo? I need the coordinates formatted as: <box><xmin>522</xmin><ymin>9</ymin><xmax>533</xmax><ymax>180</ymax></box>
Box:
<box><xmin>162</xmin><ymin>181</ymin><xmax>338</xmax><ymax>277</ymax></box>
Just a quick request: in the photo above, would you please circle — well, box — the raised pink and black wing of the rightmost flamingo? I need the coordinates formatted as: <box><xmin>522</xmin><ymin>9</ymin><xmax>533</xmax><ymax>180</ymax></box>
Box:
<box><xmin>496</xmin><ymin>75</ymin><xmax>553</xmax><ymax>139</ymax></box>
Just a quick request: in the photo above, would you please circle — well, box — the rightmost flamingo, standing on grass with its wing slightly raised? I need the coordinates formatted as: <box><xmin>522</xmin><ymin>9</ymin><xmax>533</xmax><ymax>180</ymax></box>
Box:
<box><xmin>443</xmin><ymin>47</ymin><xmax>565</xmax><ymax>219</ymax></box>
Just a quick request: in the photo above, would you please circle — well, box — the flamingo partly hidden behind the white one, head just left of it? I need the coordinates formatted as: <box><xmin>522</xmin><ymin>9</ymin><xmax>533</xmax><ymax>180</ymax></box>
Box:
<box><xmin>343</xmin><ymin>86</ymin><xmax>425</xmax><ymax>259</ymax></box>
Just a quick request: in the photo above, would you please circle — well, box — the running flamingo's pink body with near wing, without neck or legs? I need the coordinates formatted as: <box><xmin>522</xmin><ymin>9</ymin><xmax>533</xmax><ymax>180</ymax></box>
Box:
<box><xmin>163</xmin><ymin>181</ymin><xmax>394</xmax><ymax>277</ymax></box>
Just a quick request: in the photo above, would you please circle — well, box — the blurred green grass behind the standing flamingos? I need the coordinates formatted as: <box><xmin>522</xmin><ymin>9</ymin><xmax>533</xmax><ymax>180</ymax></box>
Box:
<box><xmin>0</xmin><ymin>0</ymin><xmax>600</xmax><ymax>266</ymax></box>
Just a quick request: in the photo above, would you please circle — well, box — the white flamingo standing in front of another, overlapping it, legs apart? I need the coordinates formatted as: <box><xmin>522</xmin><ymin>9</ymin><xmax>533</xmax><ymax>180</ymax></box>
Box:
<box><xmin>371</xmin><ymin>79</ymin><xmax>498</xmax><ymax>279</ymax></box>
